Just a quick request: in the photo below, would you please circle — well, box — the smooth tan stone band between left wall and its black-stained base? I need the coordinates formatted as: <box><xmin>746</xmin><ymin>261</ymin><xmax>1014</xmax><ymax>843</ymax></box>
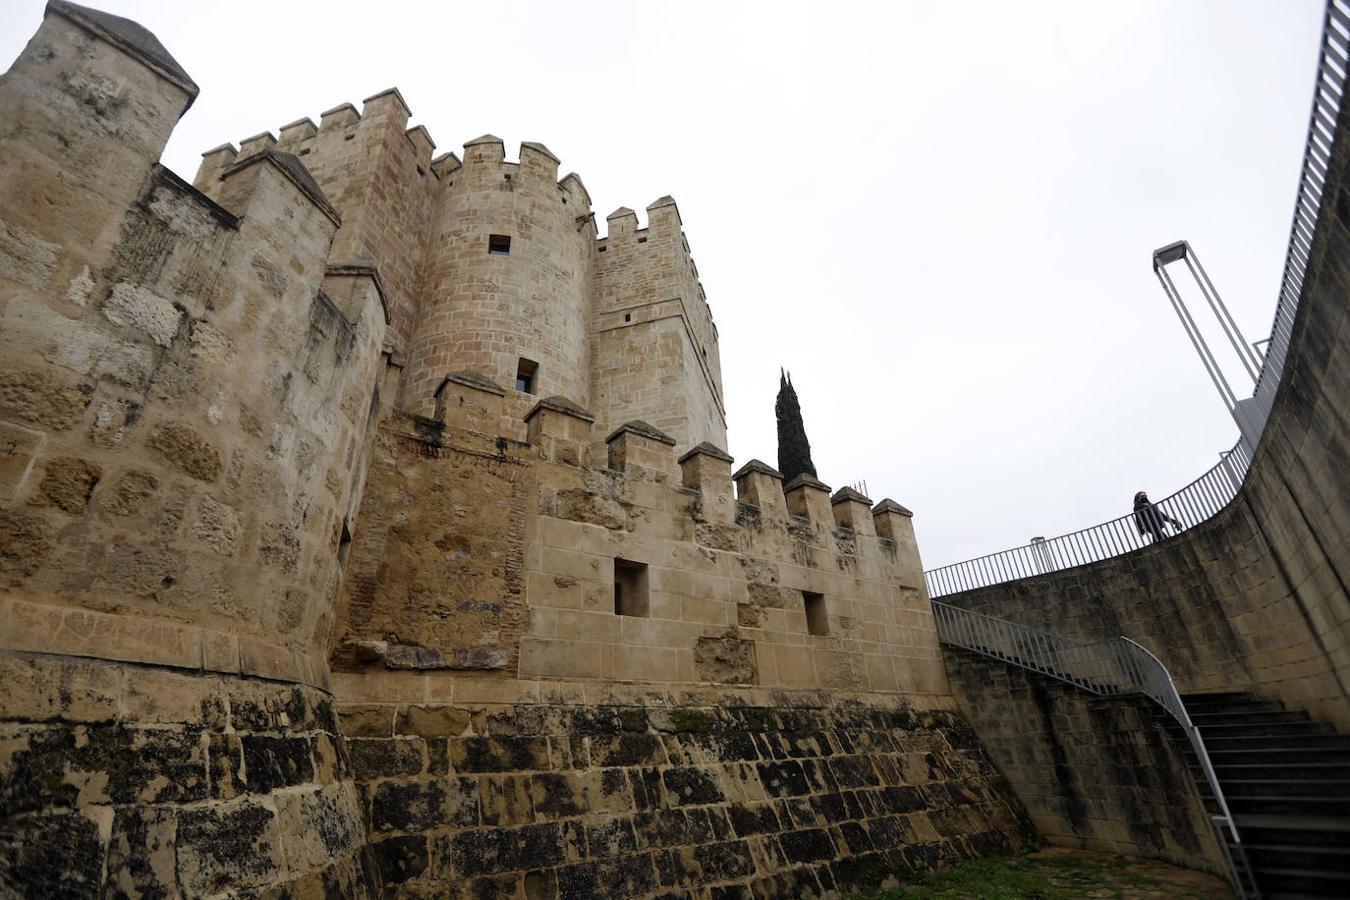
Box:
<box><xmin>0</xmin><ymin>598</ymin><xmax>328</xmax><ymax>691</ymax></box>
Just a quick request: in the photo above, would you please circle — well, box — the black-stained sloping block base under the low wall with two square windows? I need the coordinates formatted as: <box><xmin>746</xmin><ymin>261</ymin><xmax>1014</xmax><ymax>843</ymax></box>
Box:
<box><xmin>340</xmin><ymin>702</ymin><xmax>1034</xmax><ymax>899</ymax></box>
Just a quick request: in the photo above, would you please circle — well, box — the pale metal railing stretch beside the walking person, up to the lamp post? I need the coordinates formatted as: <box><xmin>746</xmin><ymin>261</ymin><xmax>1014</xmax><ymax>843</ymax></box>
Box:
<box><xmin>923</xmin><ymin>441</ymin><xmax>1251</xmax><ymax>598</ymax></box>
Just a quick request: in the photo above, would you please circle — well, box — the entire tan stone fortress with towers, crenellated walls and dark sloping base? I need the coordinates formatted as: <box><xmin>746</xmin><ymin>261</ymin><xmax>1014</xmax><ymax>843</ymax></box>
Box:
<box><xmin>0</xmin><ymin>0</ymin><xmax>1344</xmax><ymax>899</ymax></box>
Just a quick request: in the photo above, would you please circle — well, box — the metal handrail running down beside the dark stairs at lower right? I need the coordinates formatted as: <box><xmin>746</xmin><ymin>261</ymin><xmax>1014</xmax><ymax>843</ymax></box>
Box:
<box><xmin>933</xmin><ymin>600</ymin><xmax>1260</xmax><ymax>897</ymax></box>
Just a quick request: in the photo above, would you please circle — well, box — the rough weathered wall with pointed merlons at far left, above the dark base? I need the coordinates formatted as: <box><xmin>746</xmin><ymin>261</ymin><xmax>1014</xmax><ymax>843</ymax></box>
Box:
<box><xmin>0</xmin><ymin>0</ymin><xmax>385</xmax><ymax>684</ymax></box>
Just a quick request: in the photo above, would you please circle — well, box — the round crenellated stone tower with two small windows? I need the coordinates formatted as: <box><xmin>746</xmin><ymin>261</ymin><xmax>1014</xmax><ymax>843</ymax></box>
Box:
<box><xmin>405</xmin><ymin>135</ymin><xmax>595</xmax><ymax>414</ymax></box>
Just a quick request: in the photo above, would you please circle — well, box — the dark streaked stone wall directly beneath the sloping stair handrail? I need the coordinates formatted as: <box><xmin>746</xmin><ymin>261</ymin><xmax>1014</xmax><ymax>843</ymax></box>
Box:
<box><xmin>945</xmin><ymin>648</ymin><xmax>1224</xmax><ymax>874</ymax></box>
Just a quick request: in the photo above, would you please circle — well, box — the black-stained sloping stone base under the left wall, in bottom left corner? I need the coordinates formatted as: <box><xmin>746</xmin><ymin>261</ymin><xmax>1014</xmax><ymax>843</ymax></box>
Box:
<box><xmin>0</xmin><ymin>654</ymin><xmax>379</xmax><ymax>899</ymax></box>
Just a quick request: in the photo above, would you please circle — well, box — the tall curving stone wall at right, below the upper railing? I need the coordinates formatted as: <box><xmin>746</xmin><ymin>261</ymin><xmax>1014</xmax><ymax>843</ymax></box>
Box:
<box><xmin>942</xmin><ymin>121</ymin><xmax>1350</xmax><ymax>729</ymax></box>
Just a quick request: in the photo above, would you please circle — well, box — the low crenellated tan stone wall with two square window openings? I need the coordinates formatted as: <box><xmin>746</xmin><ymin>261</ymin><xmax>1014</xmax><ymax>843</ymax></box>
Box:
<box><xmin>343</xmin><ymin>372</ymin><xmax>946</xmax><ymax>694</ymax></box>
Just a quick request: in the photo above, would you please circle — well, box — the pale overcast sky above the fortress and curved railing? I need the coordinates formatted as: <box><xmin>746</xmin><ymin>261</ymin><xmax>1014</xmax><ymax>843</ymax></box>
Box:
<box><xmin>0</xmin><ymin>0</ymin><xmax>1322</xmax><ymax>568</ymax></box>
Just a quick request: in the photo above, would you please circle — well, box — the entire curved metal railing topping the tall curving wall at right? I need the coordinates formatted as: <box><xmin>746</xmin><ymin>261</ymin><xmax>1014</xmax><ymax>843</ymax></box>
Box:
<box><xmin>923</xmin><ymin>0</ymin><xmax>1350</xmax><ymax>598</ymax></box>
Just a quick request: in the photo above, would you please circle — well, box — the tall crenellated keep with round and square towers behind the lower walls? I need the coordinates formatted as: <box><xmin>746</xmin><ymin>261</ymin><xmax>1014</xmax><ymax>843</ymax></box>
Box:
<box><xmin>194</xmin><ymin>101</ymin><xmax>726</xmax><ymax>451</ymax></box>
